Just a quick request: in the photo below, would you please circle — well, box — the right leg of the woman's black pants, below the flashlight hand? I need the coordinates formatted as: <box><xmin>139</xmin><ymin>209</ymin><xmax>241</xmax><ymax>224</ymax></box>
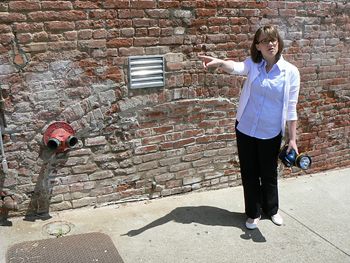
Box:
<box><xmin>258</xmin><ymin>134</ymin><xmax>282</xmax><ymax>216</ymax></box>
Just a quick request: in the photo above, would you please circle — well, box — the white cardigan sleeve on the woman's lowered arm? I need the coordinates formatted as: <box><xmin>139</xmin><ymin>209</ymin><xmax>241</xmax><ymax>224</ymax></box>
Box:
<box><xmin>287</xmin><ymin>67</ymin><xmax>300</xmax><ymax>121</ymax></box>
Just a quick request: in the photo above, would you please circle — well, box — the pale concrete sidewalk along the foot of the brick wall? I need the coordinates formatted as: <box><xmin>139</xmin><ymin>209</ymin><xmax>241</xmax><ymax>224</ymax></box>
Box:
<box><xmin>0</xmin><ymin>169</ymin><xmax>350</xmax><ymax>263</ymax></box>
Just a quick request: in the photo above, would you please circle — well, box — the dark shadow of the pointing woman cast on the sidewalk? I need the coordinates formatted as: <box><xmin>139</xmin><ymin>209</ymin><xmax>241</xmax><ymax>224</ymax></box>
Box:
<box><xmin>123</xmin><ymin>206</ymin><xmax>266</xmax><ymax>242</ymax></box>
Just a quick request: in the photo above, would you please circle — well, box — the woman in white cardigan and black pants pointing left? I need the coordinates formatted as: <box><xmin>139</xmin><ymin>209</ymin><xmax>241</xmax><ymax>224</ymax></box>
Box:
<box><xmin>199</xmin><ymin>26</ymin><xmax>300</xmax><ymax>229</ymax></box>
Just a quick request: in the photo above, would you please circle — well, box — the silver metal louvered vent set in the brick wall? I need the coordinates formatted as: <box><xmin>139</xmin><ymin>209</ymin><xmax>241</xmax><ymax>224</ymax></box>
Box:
<box><xmin>129</xmin><ymin>56</ymin><xmax>165</xmax><ymax>89</ymax></box>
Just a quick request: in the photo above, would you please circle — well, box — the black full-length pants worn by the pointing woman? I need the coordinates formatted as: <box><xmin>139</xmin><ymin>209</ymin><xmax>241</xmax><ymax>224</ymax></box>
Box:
<box><xmin>236</xmin><ymin>123</ymin><xmax>282</xmax><ymax>219</ymax></box>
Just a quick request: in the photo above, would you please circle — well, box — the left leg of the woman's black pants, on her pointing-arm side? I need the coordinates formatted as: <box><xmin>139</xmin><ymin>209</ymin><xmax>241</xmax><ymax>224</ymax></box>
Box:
<box><xmin>236</xmin><ymin>125</ymin><xmax>261</xmax><ymax>219</ymax></box>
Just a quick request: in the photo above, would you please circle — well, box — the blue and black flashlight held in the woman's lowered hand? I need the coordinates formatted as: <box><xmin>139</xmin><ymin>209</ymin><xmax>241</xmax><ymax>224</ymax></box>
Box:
<box><xmin>278</xmin><ymin>144</ymin><xmax>312</xmax><ymax>170</ymax></box>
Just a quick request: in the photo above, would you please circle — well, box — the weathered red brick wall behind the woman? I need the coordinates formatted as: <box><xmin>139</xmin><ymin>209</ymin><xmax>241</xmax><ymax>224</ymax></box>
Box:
<box><xmin>0</xmin><ymin>0</ymin><xmax>350</xmax><ymax>218</ymax></box>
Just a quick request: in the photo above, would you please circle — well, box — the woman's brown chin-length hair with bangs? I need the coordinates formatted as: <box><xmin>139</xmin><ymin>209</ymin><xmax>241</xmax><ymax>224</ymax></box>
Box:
<box><xmin>250</xmin><ymin>26</ymin><xmax>284</xmax><ymax>63</ymax></box>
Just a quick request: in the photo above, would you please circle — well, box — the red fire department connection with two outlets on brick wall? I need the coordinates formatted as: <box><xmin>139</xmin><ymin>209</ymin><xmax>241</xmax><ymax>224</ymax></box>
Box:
<box><xmin>44</xmin><ymin>122</ymin><xmax>78</xmax><ymax>152</ymax></box>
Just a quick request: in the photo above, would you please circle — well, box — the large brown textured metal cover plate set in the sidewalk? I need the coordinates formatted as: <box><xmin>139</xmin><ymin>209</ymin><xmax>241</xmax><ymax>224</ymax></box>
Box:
<box><xmin>6</xmin><ymin>233</ymin><xmax>123</xmax><ymax>263</ymax></box>
